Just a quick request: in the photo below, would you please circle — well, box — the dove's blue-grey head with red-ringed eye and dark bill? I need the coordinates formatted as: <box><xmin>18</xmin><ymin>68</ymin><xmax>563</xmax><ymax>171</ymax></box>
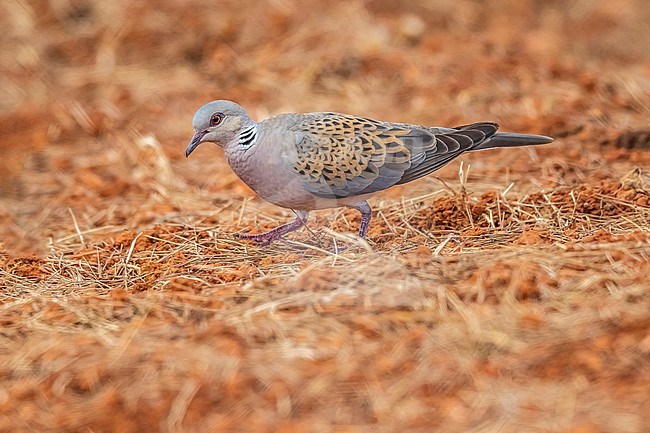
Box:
<box><xmin>185</xmin><ymin>100</ymin><xmax>255</xmax><ymax>156</ymax></box>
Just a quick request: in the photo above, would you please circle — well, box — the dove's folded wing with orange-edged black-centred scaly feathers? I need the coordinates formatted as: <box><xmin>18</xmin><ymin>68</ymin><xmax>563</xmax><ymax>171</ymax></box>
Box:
<box><xmin>289</xmin><ymin>113</ymin><xmax>498</xmax><ymax>198</ymax></box>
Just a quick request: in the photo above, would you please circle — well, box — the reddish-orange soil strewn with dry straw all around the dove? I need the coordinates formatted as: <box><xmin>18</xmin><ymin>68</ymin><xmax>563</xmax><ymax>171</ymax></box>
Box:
<box><xmin>0</xmin><ymin>0</ymin><xmax>650</xmax><ymax>432</ymax></box>
